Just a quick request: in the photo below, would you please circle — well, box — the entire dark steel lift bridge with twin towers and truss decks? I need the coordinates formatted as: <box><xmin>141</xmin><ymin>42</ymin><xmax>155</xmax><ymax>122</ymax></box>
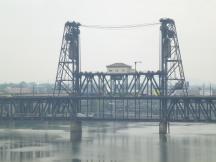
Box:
<box><xmin>0</xmin><ymin>19</ymin><xmax>216</xmax><ymax>133</ymax></box>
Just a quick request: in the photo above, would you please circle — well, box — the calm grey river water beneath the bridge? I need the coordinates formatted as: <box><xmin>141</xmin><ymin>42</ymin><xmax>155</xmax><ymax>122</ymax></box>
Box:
<box><xmin>0</xmin><ymin>121</ymin><xmax>216</xmax><ymax>162</ymax></box>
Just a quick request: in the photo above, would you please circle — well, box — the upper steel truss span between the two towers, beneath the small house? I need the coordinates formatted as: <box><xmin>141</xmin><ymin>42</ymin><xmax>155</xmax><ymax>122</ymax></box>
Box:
<box><xmin>80</xmin><ymin>72</ymin><xmax>160</xmax><ymax>97</ymax></box>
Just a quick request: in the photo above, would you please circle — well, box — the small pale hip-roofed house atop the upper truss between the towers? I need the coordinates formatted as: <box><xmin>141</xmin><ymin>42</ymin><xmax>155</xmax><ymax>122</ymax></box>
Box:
<box><xmin>106</xmin><ymin>63</ymin><xmax>134</xmax><ymax>73</ymax></box>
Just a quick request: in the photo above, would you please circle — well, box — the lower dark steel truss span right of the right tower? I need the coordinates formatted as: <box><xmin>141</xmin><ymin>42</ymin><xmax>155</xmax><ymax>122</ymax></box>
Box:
<box><xmin>167</xmin><ymin>97</ymin><xmax>216</xmax><ymax>121</ymax></box>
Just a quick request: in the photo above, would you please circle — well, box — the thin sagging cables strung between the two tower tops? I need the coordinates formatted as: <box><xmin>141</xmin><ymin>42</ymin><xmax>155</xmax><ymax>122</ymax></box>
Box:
<box><xmin>81</xmin><ymin>22</ymin><xmax>160</xmax><ymax>29</ymax></box>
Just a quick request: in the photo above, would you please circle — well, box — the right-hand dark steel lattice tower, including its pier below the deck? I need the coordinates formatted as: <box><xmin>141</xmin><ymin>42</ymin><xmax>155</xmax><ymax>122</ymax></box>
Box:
<box><xmin>159</xmin><ymin>18</ymin><xmax>187</xmax><ymax>133</ymax></box>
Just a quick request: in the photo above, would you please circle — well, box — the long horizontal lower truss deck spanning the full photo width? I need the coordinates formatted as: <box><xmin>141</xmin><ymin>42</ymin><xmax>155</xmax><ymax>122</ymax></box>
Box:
<box><xmin>0</xmin><ymin>96</ymin><xmax>216</xmax><ymax>122</ymax></box>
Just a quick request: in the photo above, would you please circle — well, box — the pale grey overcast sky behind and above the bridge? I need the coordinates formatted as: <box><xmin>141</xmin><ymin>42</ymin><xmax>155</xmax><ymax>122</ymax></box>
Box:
<box><xmin>0</xmin><ymin>0</ymin><xmax>216</xmax><ymax>83</ymax></box>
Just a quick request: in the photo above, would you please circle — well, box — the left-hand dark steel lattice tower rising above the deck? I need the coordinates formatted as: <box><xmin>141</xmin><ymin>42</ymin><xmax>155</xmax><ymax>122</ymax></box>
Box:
<box><xmin>53</xmin><ymin>21</ymin><xmax>80</xmax><ymax>114</ymax></box>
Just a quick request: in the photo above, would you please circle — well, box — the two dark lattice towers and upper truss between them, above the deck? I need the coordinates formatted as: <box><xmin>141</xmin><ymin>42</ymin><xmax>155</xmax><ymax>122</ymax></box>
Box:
<box><xmin>54</xmin><ymin>19</ymin><xmax>187</xmax><ymax>96</ymax></box>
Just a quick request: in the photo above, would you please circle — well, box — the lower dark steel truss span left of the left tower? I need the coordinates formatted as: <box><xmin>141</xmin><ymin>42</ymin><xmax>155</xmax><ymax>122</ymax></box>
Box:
<box><xmin>0</xmin><ymin>96</ymin><xmax>78</xmax><ymax>119</ymax></box>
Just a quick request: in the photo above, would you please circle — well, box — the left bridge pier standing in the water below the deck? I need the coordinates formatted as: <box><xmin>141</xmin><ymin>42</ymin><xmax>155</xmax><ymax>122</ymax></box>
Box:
<box><xmin>70</xmin><ymin>120</ymin><xmax>82</xmax><ymax>142</ymax></box>
